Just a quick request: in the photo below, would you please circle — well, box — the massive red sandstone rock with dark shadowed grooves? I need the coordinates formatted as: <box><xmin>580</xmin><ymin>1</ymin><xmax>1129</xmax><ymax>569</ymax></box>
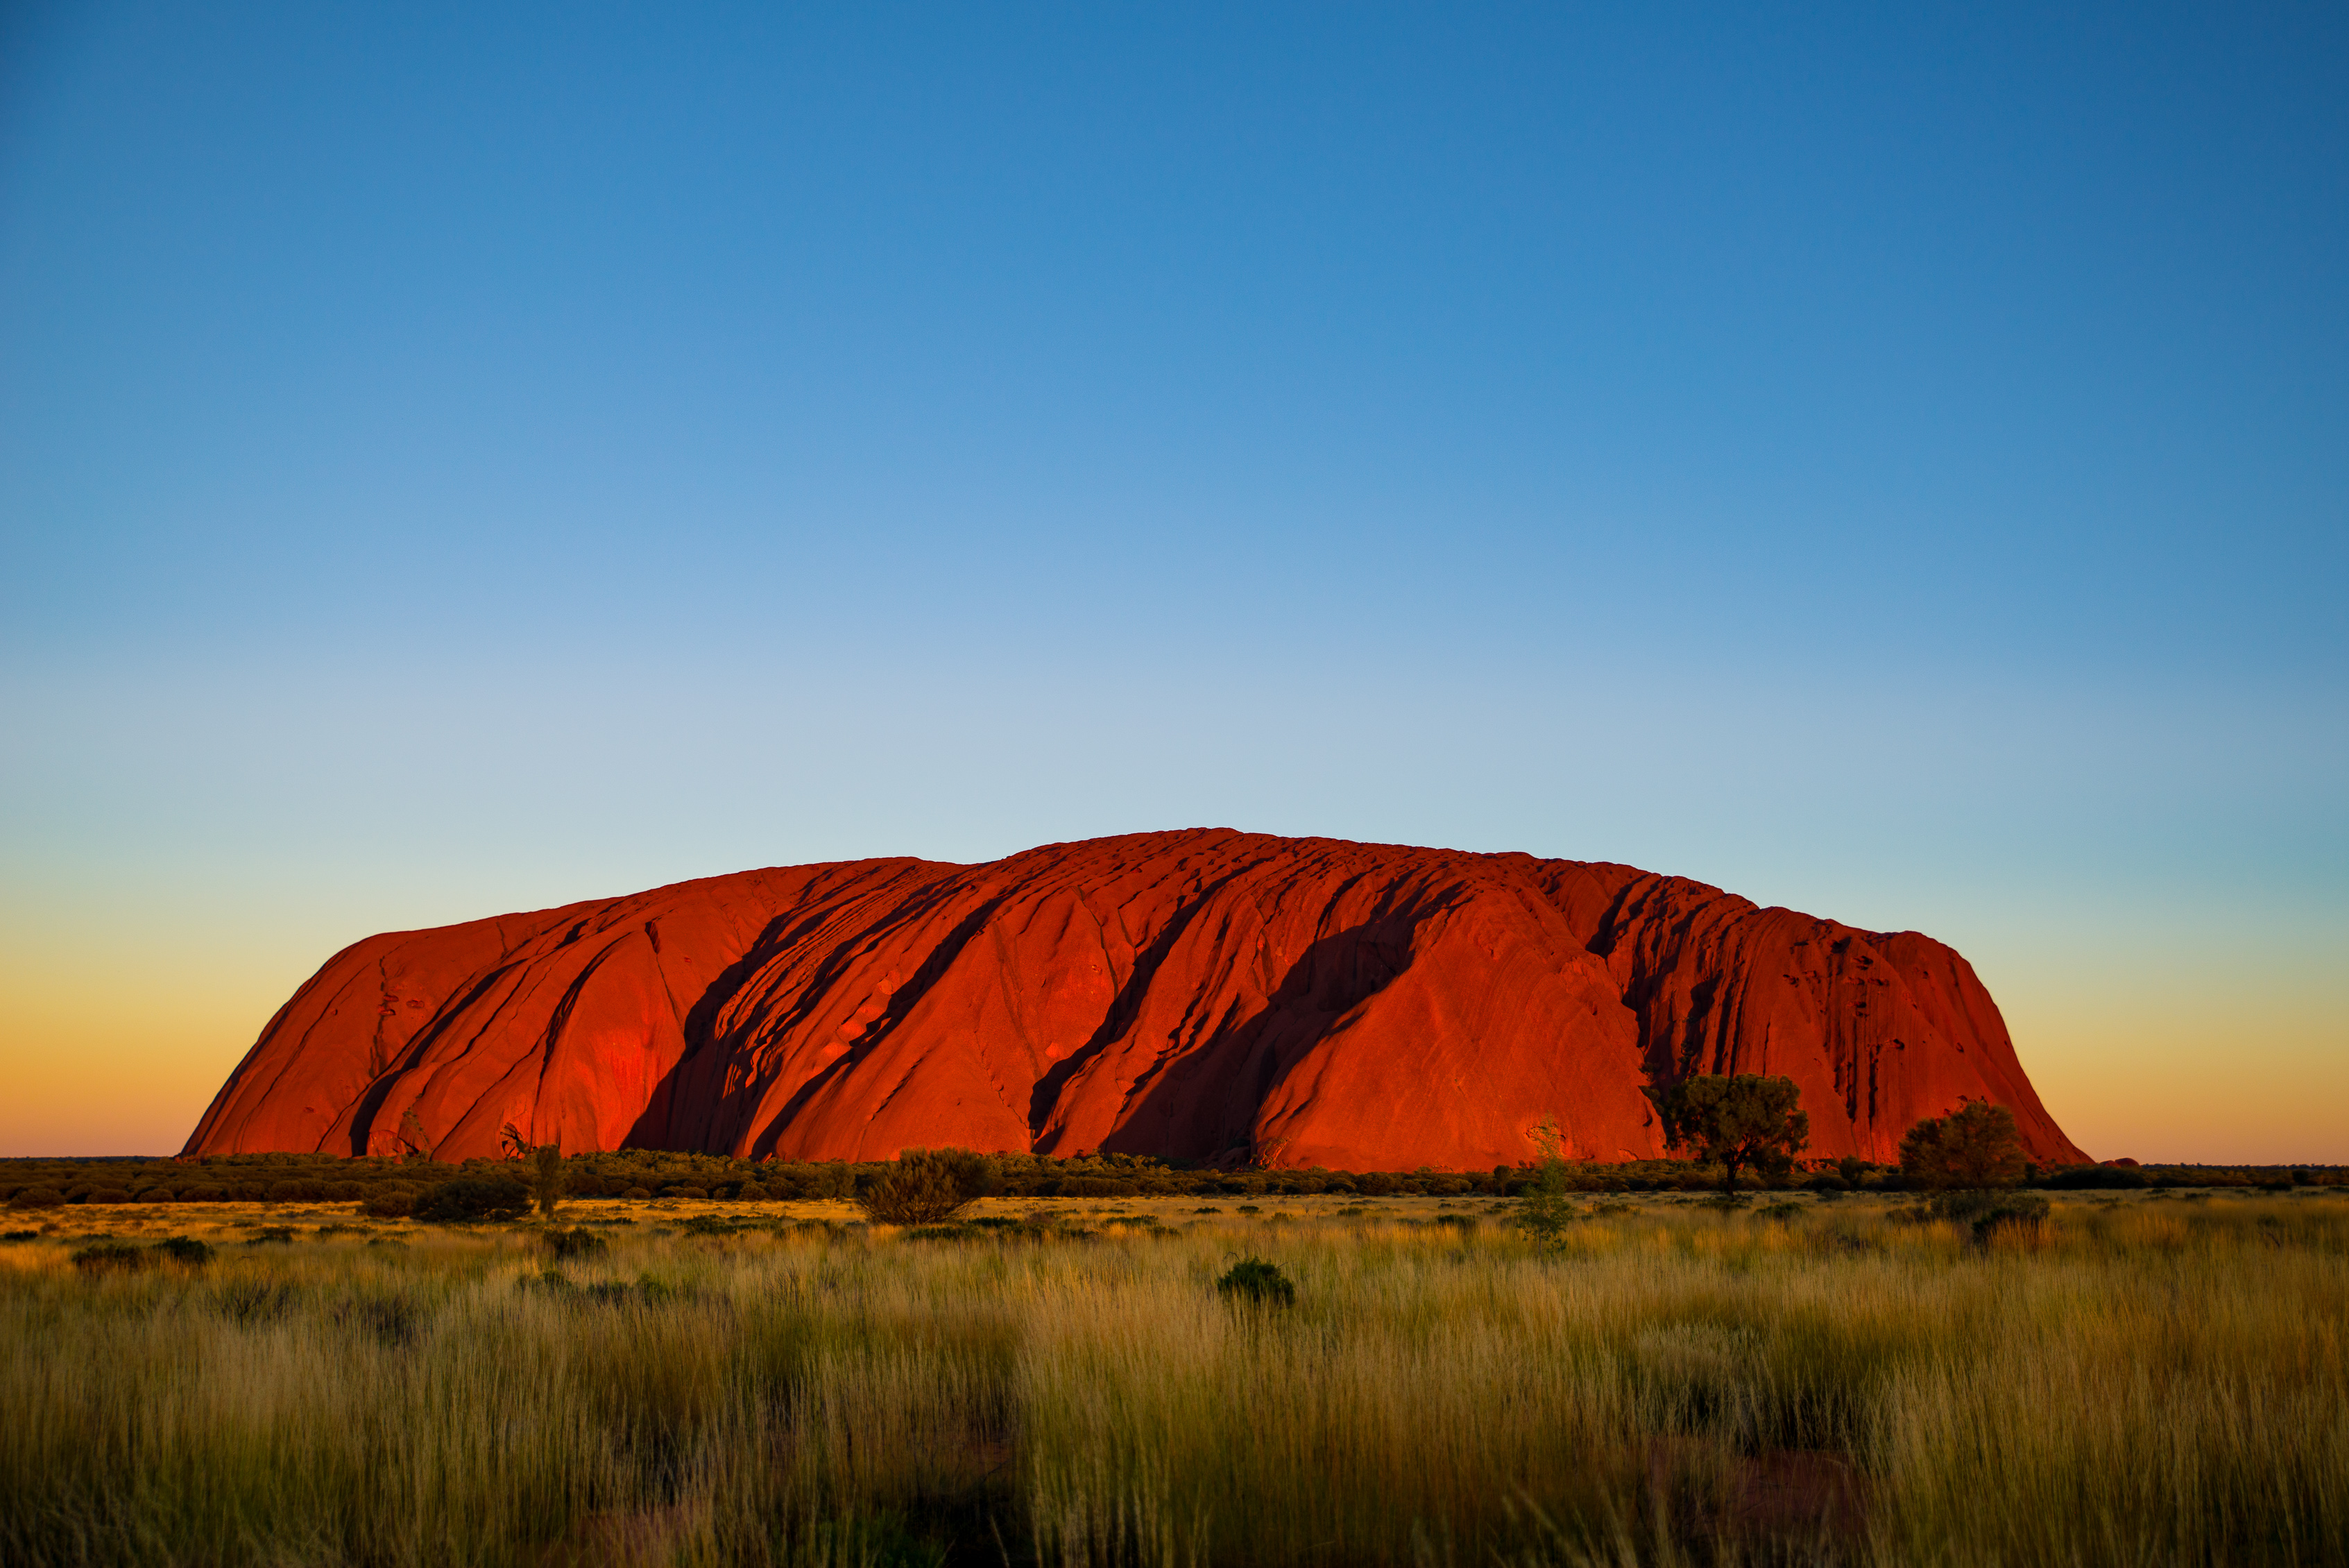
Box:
<box><xmin>188</xmin><ymin>830</ymin><xmax>2086</xmax><ymax>1170</ymax></box>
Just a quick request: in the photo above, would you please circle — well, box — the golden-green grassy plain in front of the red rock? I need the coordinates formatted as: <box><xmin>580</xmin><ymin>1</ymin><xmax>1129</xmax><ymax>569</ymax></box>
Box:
<box><xmin>0</xmin><ymin>1189</ymin><xmax>2349</xmax><ymax>1568</ymax></box>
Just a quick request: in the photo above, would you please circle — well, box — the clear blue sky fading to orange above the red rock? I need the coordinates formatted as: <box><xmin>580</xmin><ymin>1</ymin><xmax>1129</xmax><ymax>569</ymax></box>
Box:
<box><xmin>0</xmin><ymin>0</ymin><xmax>2349</xmax><ymax>1161</ymax></box>
